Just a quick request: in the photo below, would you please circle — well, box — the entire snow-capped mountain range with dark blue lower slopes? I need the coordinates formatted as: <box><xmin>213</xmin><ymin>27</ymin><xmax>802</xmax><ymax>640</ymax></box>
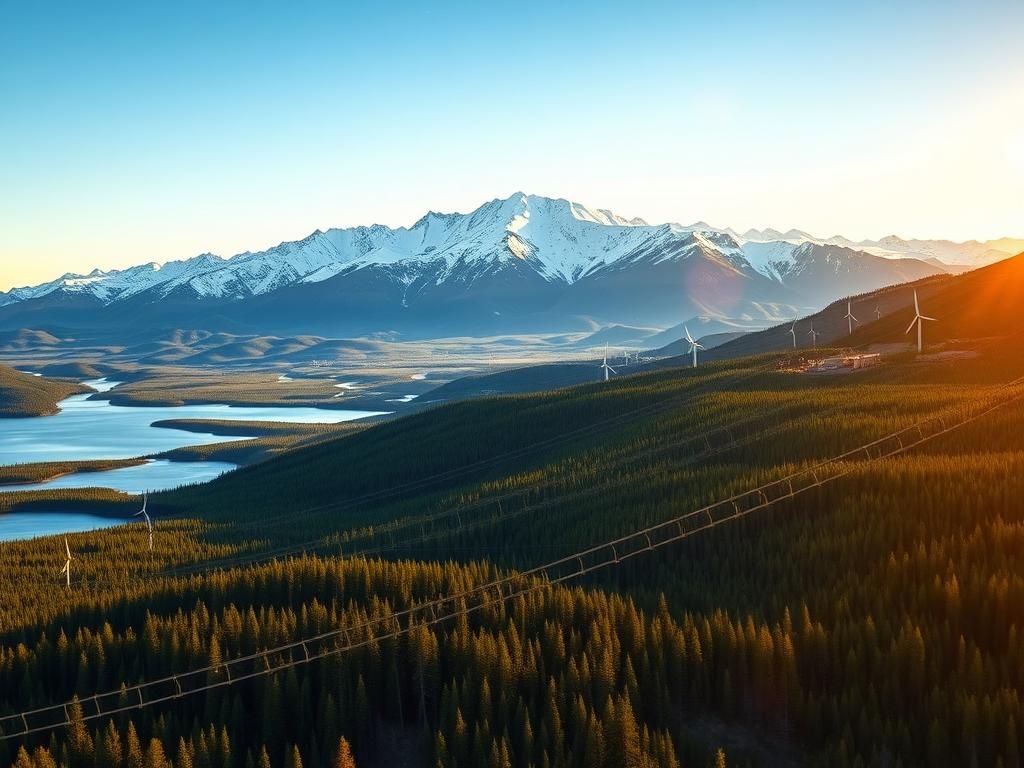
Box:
<box><xmin>0</xmin><ymin>194</ymin><xmax>1024</xmax><ymax>333</ymax></box>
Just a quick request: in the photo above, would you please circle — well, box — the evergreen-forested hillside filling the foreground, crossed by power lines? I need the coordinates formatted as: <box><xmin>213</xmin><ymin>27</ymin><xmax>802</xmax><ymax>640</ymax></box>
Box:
<box><xmin>0</xmin><ymin>311</ymin><xmax>1024</xmax><ymax>768</ymax></box>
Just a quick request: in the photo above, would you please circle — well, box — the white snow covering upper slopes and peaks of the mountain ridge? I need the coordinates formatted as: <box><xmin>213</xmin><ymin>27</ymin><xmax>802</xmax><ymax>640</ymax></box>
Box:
<box><xmin>6</xmin><ymin>193</ymin><xmax>1019</xmax><ymax>304</ymax></box>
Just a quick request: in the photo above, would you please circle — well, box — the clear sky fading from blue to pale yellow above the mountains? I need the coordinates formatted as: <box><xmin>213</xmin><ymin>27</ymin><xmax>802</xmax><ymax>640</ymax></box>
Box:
<box><xmin>0</xmin><ymin>0</ymin><xmax>1024</xmax><ymax>290</ymax></box>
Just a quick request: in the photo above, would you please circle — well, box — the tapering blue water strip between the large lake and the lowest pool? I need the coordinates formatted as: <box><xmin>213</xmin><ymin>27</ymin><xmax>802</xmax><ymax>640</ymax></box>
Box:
<box><xmin>0</xmin><ymin>459</ymin><xmax>238</xmax><ymax>494</ymax></box>
